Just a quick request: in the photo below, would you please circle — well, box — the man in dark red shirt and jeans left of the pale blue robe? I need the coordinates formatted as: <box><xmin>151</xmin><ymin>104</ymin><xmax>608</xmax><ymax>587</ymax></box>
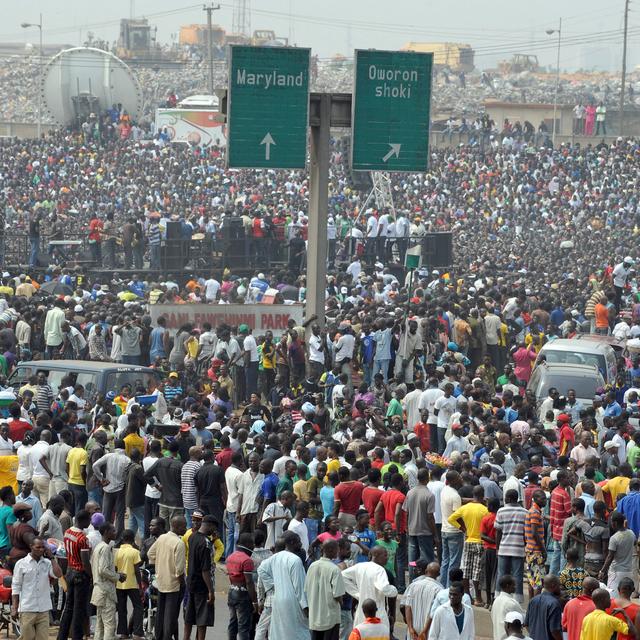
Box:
<box><xmin>226</xmin><ymin>533</ymin><xmax>258</xmax><ymax>638</ymax></box>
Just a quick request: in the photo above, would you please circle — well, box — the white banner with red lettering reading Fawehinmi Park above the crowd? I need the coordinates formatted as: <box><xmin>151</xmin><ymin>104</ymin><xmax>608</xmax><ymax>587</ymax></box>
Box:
<box><xmin>149</xmin><ymin>304</ymin><xmax>304</xmax><ymax>336</ymax></box>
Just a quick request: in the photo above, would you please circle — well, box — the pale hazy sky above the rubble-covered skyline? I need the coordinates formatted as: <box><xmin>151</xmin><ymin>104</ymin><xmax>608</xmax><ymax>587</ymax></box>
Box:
<box><xmin>0</xmin><ymin>0</ymin><xmax>640</xmax><ymax>70</ymax></box>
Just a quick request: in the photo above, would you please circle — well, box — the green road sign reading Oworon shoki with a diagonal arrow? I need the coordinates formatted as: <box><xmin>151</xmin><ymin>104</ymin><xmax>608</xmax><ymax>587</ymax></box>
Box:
<box><xmin>351</xmin><ymin>50</ymin><xmax>433</xmax><ymax>171</ymax></box>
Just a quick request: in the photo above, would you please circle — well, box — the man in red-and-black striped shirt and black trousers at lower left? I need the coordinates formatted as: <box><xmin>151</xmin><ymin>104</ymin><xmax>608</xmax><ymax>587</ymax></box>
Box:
<box><xmin>58</xmin><ymin>509</ymin><xmax>91</xmax><ymax>640</ymax></box>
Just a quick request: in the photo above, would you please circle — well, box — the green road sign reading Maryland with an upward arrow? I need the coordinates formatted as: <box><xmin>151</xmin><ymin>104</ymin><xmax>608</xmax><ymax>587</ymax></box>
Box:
<box><xmin>227</xmin><ymin>46</ymin><xmax>310</xmax><ymax>169</ymax></box>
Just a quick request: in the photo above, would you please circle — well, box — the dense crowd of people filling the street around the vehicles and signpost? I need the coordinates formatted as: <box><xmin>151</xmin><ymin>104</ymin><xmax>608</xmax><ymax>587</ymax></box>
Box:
<box><xmin>0</xmin><ymin>56</ymin><xmax>640</xmax><ymax>640</ymax></box>
